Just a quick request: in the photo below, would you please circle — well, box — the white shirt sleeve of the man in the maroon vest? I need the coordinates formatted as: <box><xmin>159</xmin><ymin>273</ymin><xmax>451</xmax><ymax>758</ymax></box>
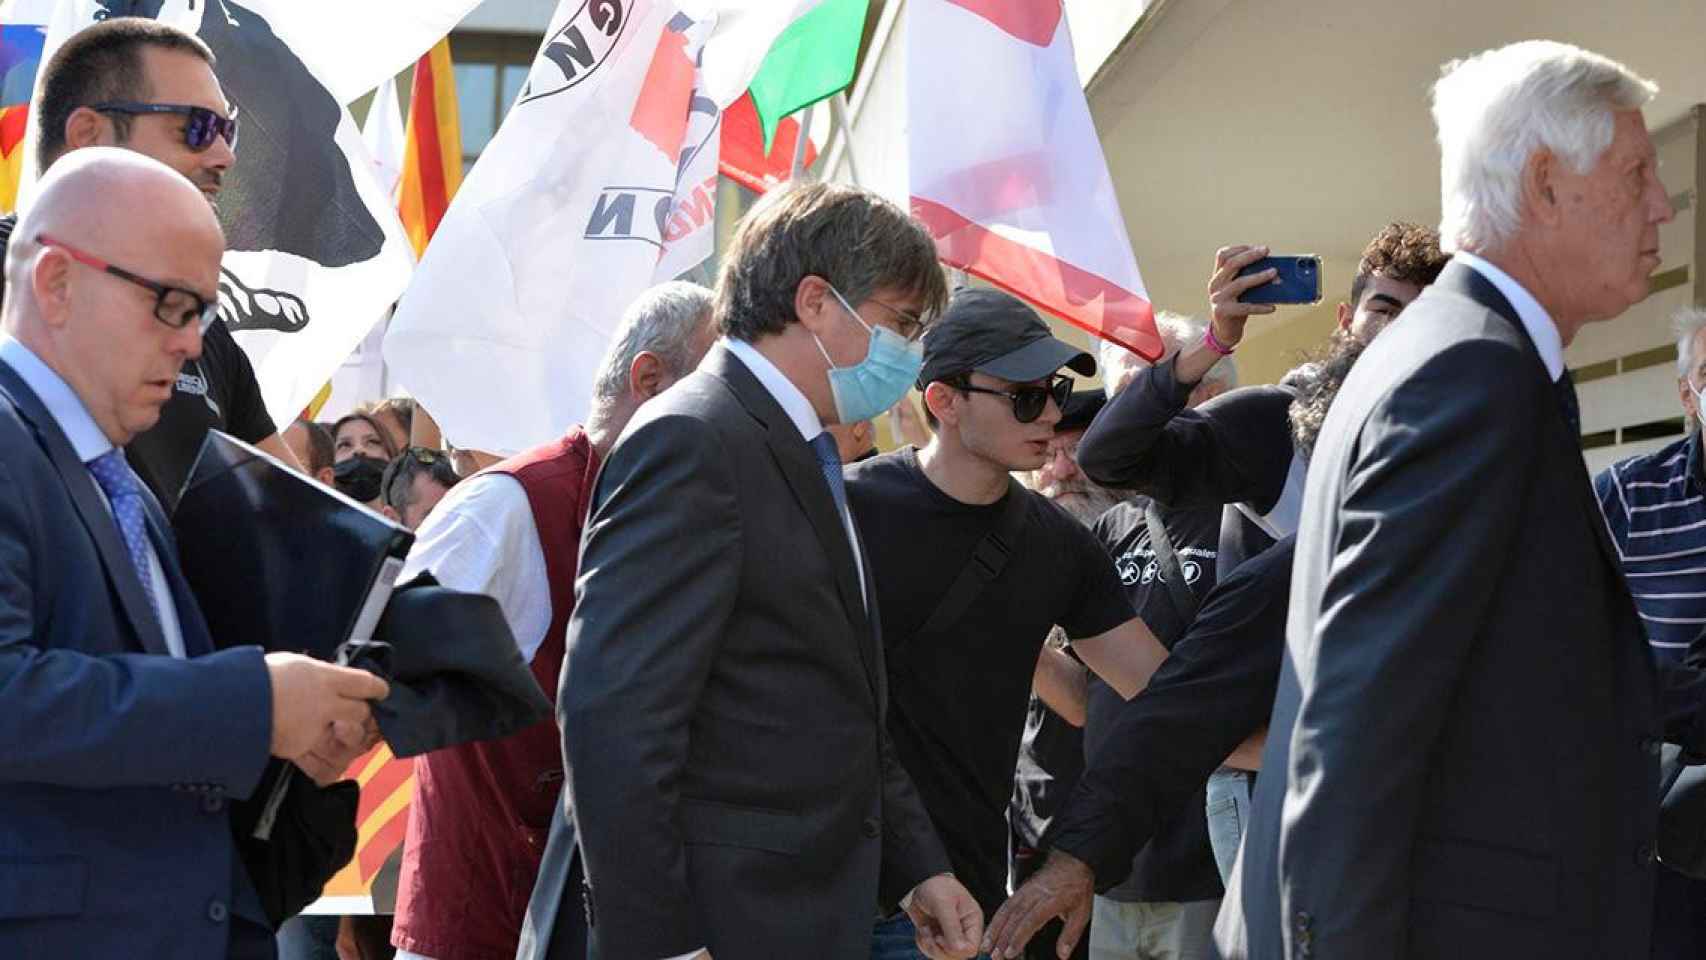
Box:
<box><xmin>397</xmin><ymin>472</ymin><xmax>551</xmax><ymax>663</ymax></box>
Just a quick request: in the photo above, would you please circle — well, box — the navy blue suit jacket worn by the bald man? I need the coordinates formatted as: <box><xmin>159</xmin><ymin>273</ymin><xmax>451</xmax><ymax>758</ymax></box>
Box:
<box><xmin>0</xmin><ymin>363</ymin><xmax>271</xmax><ymax>958</ymax></box>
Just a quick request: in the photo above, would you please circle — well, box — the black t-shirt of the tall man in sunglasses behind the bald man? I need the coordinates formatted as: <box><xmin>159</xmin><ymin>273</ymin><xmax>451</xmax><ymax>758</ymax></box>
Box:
<box><xmin>125</xmin><ymin>321</ymin><xmax>278</xmax><ymax>513</ymax></box>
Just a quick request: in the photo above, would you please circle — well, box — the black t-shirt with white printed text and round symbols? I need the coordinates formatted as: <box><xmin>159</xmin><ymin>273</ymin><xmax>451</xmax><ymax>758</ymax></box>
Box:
<box><xmin>1083</xmin><ymin>496</ymin><xmax>1223</xmax><ymax>904</ymax></box>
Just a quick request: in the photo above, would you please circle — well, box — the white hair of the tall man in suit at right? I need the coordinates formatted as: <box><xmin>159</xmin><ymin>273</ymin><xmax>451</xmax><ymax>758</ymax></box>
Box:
<box><xmin>1433</xmin><ymin>39</ymin><xmax>1658</xmax><ymax>252</ymax></box>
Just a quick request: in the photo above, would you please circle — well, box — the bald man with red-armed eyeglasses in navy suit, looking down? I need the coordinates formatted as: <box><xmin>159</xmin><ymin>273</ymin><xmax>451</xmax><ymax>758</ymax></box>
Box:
<box><xmin>0</xmin><ymin>148</ymin><xmax>387</xmax><ymax>960</ymax></box>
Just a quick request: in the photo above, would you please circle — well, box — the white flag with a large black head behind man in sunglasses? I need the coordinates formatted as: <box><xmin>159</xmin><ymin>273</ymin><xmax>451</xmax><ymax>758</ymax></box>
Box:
<box><xmin>31</xmin><ymin>0</ymin><xmax>478</xmax><ymax>423</ymax></box>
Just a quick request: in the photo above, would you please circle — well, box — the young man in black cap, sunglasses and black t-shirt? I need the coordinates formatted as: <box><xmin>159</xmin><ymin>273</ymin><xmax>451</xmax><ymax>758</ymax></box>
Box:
<box><xmin>846</xmin><ymin>290</ymin><xmax>1165</xmax><ymax>960</ymax></box>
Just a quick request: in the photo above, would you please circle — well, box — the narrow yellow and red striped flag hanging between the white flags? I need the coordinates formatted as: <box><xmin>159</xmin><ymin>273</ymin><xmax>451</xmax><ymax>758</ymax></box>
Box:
<box><xmin>397</xmin><ymin>38</ymin><xmax>462</xmax><ymax>257</ymax></box>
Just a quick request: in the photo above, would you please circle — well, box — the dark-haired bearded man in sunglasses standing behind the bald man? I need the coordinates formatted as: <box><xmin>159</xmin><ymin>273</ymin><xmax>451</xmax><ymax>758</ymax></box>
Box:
<box><xmin>0</xmin><ymin>17</ymin><xmax>300</xmax><ymax>512</ymax></box>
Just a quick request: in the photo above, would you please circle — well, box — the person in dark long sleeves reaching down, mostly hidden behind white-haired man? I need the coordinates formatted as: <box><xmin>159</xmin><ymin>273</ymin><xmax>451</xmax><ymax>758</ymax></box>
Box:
<box><xmin>984</xmin><ymin>325</ymin><xmax>1367</xmax><ymax>960</ymax></box>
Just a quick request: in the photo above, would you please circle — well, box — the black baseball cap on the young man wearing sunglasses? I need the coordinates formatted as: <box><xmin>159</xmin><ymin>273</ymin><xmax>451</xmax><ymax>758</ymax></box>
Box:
<box><xmin>918</xmin><ymin>288</ymin><xmax>1095</xmax><ymax>390</ymax></box>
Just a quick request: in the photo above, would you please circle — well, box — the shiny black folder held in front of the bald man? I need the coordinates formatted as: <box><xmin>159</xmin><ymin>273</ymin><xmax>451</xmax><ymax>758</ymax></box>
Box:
<box><xmin>172</xmin><ymin>430</ymin><xmax>415</xmax><ymax>660</ymax></box>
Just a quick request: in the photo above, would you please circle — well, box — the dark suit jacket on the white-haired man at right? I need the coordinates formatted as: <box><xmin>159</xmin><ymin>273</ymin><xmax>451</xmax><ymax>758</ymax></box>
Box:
<box><xmin>1216</xmin><ymin>263</ymin><xmax>1660</xmax><ymax>960</ymax></box>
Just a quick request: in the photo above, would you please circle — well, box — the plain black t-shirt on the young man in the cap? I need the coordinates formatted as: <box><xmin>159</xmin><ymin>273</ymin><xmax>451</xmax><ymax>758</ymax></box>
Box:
<box><xmin>846</xmin><ymin>447</ymin><xmax>1133</xmax><ymax>916</ymax></box>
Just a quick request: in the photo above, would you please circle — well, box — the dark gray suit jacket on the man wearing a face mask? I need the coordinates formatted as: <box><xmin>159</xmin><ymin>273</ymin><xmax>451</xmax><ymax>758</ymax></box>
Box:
<box><xmin>558</xmin><ymin>348</ymin><xmax>949</xmax><ymax>960</ymax></box>
